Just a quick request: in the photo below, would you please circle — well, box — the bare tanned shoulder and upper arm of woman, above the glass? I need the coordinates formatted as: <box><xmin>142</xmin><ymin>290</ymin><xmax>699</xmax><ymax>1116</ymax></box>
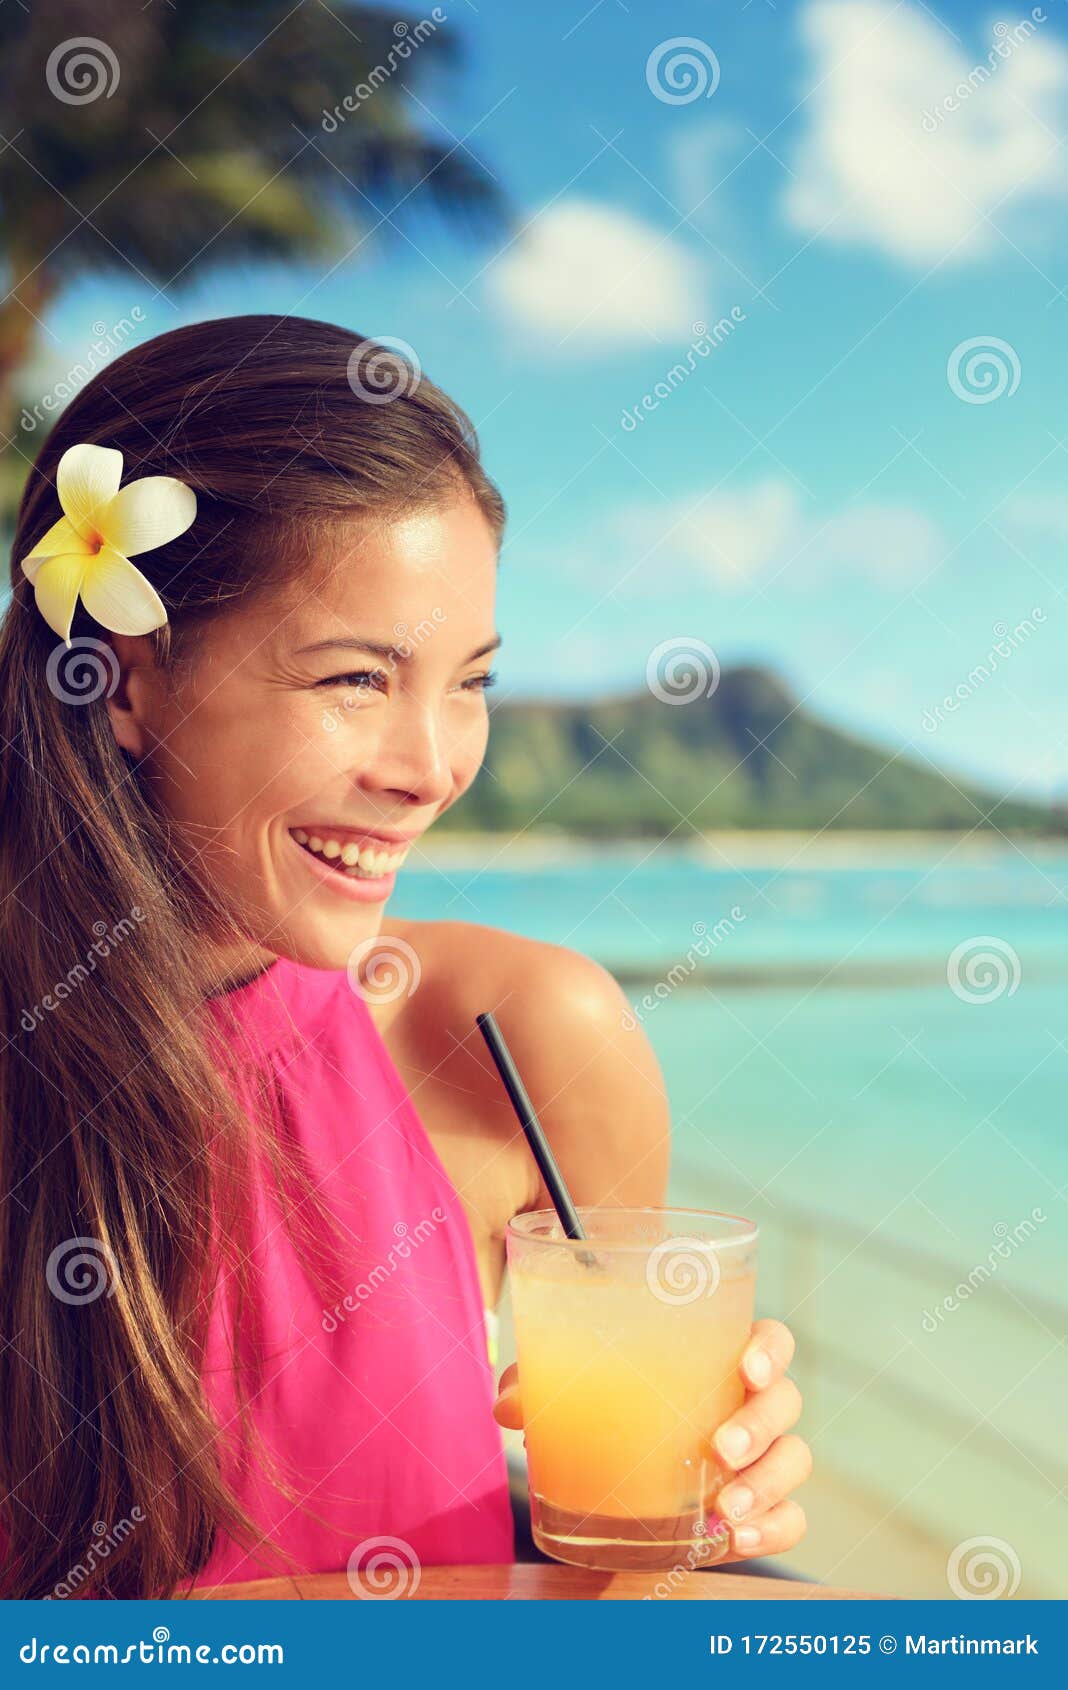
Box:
<box><xmin>390</xmin><ymin>921</ymin><xmax>671</xmax><ymax>1207</ymax></box>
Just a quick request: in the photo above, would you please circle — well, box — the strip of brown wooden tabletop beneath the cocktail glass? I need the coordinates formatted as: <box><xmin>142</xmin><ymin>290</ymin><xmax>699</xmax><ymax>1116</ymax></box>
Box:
<box><xmin>194</xmin><ymin>1562</ymin><xmax>867</xmax><ymax>1602</ymax></box>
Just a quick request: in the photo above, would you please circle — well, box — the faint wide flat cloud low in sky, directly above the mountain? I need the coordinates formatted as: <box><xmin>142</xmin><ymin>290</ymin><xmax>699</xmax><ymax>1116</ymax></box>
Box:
<box><xmin>613</xmin><ymin>478</ymin><xmax>946</xmax><ymax>592</ymax></box>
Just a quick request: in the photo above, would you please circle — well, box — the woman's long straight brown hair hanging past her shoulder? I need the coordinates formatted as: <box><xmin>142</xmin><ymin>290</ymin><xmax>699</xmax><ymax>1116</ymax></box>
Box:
<box><xmin>0</xmin><ymin>316</ymin><xmax>505</xmax><ymax>1599</ymax></box>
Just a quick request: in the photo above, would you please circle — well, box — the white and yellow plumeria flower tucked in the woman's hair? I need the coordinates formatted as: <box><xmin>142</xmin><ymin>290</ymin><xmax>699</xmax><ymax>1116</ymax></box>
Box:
<box><xmin>22</xmin><ymin>443</ymin><xmax>196</xmax><ymax>646</ymax></box>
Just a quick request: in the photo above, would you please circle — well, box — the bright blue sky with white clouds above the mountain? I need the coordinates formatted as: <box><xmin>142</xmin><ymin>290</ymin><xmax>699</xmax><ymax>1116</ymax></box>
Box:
<box><xmin>22</xmin><ymin>0</ymin><xmax>1068</xmax><ymax>794</ymax></box>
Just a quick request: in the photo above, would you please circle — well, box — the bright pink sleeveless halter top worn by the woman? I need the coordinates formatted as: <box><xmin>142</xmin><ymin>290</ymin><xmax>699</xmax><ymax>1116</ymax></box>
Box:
<box><xmin>181</xmin><ymin>958</ymin><xmax>514</xmax><ymax>1589</ymax></box>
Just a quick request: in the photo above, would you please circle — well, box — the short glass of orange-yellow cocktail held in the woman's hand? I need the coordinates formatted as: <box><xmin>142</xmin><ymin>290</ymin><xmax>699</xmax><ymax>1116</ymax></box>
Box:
<box><xmin>509</xmin><ymin>1208</ymin><xmax>757</xmax><ymax>1567</ymax></box>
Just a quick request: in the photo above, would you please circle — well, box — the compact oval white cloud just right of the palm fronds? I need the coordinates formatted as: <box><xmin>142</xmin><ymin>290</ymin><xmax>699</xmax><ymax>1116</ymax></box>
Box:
<box><xmin>487</xmin><ymin>199</ymin><xmax>708</xmax><ymax>357</ymax></box>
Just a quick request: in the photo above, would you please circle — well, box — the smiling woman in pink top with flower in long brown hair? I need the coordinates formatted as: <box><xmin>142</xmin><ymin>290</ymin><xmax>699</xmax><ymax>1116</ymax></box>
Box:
<box><xmin>0</xmin><ymin>316</ymin><xmax>808</xmax><ymax>1597</ymax></box>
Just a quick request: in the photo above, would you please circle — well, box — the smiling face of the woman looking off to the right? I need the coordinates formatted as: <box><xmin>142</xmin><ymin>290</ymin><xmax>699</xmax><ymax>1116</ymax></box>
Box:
<box><xmin>113</xmin><ymin>499</ymin><xmax>499</xmax><ymax>977</ymax></box>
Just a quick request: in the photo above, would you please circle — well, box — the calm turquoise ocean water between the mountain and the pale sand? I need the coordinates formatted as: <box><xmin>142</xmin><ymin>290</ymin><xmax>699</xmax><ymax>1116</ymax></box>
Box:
<box><xmin>390</xmin><ymin>842</ymin><xmax>1068</xmax><ymax>1273</ymax></box>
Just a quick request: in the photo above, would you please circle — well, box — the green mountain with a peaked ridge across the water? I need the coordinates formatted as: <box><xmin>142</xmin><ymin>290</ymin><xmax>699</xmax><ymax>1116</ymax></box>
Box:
<box><xmin>438</xmin><ymin>668</ymin><xmax>1065</xmax><ymax>838</ymax></box>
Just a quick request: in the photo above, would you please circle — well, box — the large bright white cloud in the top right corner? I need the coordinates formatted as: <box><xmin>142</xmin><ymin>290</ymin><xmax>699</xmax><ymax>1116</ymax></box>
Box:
<box><xmin>784</xmin><ymin>0</ymin><xmax>1068</xmax><ymax>265</ymax></box>
